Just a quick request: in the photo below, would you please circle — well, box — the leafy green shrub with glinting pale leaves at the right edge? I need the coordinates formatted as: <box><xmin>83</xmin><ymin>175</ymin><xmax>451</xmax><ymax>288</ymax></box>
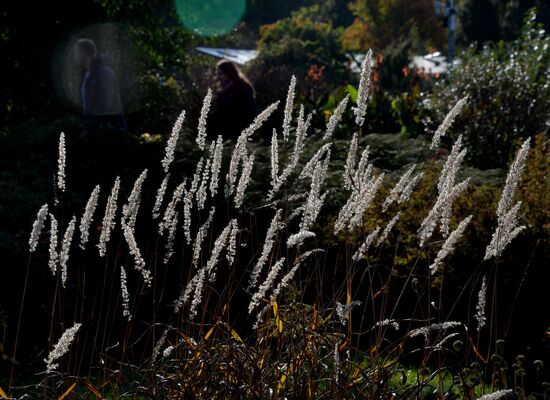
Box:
<box><xmin>425</xmin><ymin>12</ymin><xmax>550</xmax><ymax>168</ymax></box>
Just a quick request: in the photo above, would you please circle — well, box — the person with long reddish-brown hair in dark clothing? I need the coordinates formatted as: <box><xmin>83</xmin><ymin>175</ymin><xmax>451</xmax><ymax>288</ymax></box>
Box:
<box><xmin>213</xmin><ymin>60</ymin><xmax>257</xmax><ymax>140</ymax></box>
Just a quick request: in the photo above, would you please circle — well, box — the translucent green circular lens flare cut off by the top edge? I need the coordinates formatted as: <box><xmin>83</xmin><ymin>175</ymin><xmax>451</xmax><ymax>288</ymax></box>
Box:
<box><xmin>175</xmin><ymin>0</ymin><xmax>246</xmax><ymax>36</ymax></box>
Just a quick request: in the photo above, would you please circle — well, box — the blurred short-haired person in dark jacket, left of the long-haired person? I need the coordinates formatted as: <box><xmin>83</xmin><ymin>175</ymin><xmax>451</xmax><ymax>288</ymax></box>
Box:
<box><xmin>74</xmin><ymin>39</ymin><xmax>126</xmax><ymax>131</ymax></box>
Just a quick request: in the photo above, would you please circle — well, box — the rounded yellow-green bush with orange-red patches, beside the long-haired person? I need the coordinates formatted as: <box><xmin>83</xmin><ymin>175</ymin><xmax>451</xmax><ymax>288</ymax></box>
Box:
<box><xmin>250</xmin><ymin>4</ymin><xmax>350</xmax><ymax>122</ymax></box>
